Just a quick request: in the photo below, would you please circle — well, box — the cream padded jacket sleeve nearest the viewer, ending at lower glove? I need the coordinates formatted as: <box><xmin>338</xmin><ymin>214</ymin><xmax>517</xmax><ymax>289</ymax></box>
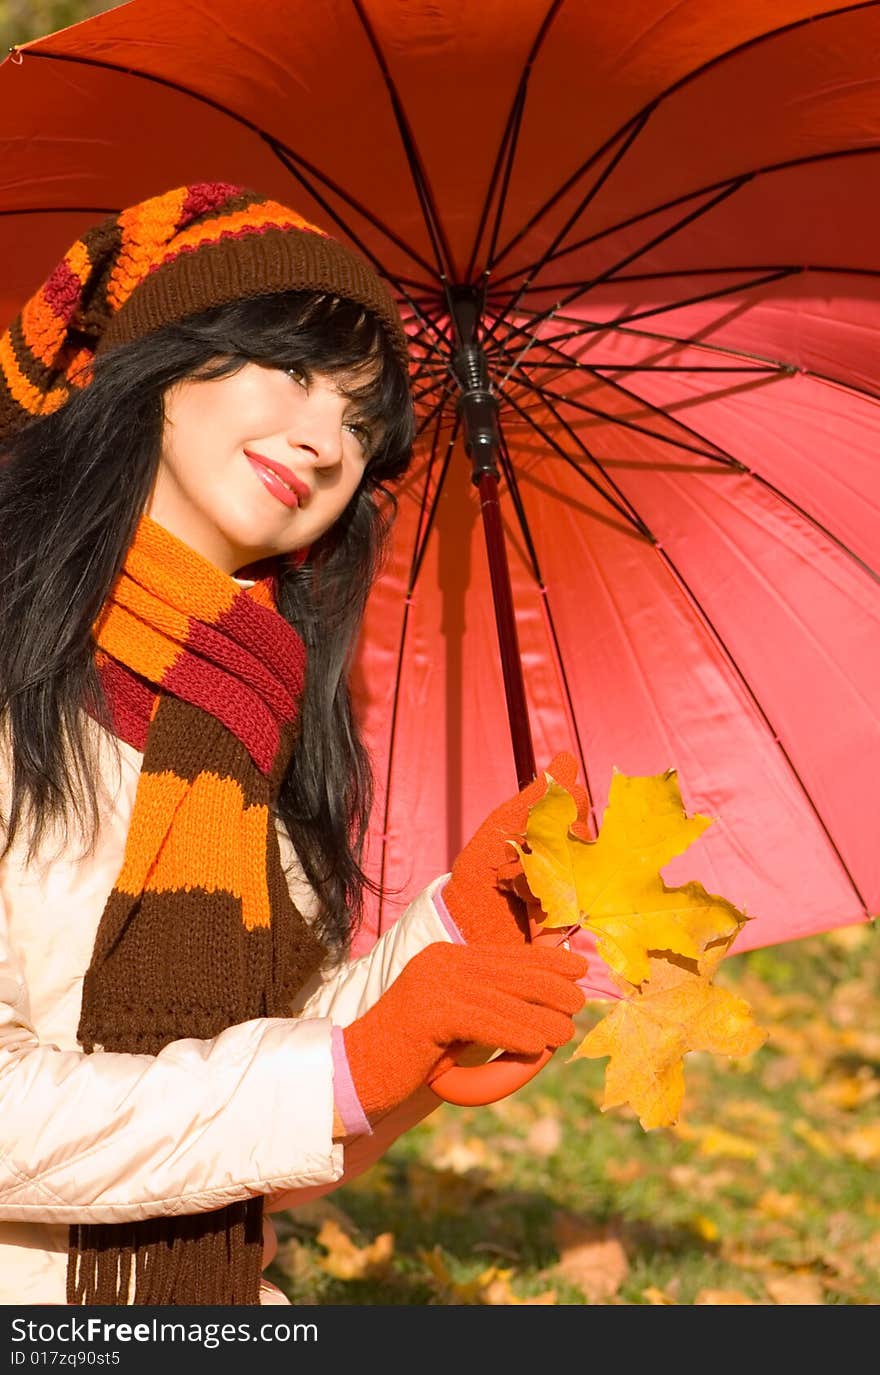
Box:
<box><xmin>0</xmin><ymin>885</ymin><xmax>344</xmax><ymax>1222</ymax></box>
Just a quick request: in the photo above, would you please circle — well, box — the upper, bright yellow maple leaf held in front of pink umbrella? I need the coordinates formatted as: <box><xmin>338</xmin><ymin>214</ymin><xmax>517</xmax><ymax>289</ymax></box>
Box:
<box><xmin>512</xmin><ymin>769</ymin><xmax>749</xmax><ymax>985</ymax></box>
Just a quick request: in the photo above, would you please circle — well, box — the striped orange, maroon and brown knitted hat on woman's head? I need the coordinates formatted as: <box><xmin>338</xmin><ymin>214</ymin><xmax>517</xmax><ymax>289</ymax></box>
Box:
<box><xmin>0</xmin><ymin>182</ymin><xmax>408</xmax><ymax>437</ymax></box>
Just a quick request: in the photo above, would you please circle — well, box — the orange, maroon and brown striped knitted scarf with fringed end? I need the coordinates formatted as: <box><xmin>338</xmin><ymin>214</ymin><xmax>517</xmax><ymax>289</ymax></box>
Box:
<box><xmin>67</xmin><ymin>516</ymin><xmax>325</xmax><ymax>1305</ymax></box>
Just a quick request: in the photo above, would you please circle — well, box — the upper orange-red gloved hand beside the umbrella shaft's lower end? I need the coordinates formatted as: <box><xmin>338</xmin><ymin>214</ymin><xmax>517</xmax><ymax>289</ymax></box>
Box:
<box><xmin>443</xmin><ymin>752</ymin><xmax>589</xmax><ymax>946</ymax></box>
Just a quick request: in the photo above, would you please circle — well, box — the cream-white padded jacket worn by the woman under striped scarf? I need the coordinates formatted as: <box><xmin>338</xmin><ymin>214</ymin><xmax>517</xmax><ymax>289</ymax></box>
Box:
<box><xmin>0</xmin><ymin>727</ymin><xmax>450</xmax><ymax>1304</ymax></box>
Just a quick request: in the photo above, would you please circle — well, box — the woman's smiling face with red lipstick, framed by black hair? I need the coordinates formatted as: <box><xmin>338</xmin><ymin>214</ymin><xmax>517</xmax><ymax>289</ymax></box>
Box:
<box><xmin>147</xmin><ymin>363</ymin><xmax>371</xmax><ymax>573</ymax></box>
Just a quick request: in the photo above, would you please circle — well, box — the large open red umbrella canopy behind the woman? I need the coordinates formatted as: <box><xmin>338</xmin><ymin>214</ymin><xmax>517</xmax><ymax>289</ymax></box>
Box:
<box><xmin>0</xmin><ymin>0</ymin><xmax>880</xmax><ymax>979</ymax></box>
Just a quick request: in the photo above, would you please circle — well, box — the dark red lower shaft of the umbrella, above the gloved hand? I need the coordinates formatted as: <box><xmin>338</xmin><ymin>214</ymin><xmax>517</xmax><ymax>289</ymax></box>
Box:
<box><xmin>476</xmin><ymin>472</ymin><xmax>535</xmax><ymax>788</ymax></box>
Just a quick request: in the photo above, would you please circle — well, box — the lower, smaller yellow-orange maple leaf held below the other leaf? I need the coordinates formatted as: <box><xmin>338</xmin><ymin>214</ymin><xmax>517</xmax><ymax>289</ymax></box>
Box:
<box><xmin>569</xmin><ymin>956</ymin><xmax>766</xmax><ymax>1130</ymax></box>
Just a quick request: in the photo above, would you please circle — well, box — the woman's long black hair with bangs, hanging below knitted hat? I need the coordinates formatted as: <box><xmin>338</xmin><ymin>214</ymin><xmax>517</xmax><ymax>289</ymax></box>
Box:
<box><xmin>0</xmin><ymin>292</ymin><xmax>414</xmax><ymax>950</ymax></box>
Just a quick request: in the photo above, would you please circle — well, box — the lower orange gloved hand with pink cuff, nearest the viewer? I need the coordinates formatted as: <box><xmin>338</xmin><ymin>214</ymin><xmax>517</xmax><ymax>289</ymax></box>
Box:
<box><xmin>344</xmin><ymin>941</ymin><xmax>587</xmax><ymax>1118</ymax></box>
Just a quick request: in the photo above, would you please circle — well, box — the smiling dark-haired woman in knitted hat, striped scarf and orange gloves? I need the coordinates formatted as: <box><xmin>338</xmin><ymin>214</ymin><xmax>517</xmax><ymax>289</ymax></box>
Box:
<box><xmin>0</xmin><ymin>183</ymin><xmax>586</xmax><ymax>1304</ymax></box>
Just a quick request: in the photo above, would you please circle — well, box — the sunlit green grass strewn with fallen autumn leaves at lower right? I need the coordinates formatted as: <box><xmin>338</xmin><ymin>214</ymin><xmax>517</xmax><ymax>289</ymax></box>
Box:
<box><xmin>270</xmin><ymin>927</ymin><xmax>880</xmax><ymax>1305</ymax></box>
